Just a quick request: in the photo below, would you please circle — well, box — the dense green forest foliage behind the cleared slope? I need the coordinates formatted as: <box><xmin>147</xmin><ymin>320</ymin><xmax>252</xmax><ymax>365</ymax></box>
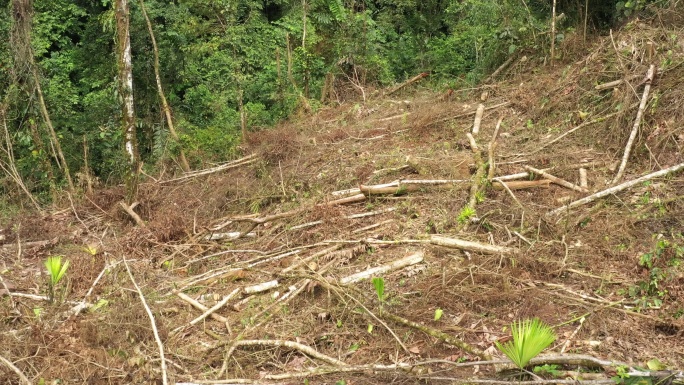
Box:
<box><xmin>0</xmin><ymin>0</ymin><xmax>664</xmax><ymax>201</ymax></box>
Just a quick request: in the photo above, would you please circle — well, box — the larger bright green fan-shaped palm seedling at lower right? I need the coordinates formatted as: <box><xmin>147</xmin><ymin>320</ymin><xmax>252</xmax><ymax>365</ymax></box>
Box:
<box><xmin>496</xmin><ymin>318</ymin><xmax>556</xmax><ymax>369</ymax></box>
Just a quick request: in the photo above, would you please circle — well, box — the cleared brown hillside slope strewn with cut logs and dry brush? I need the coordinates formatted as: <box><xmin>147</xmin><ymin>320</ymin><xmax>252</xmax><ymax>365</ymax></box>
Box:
<box><xmin>0</xmin><ymin>13</ymin><xmax>684</xmax><ymax>384</ymax></box>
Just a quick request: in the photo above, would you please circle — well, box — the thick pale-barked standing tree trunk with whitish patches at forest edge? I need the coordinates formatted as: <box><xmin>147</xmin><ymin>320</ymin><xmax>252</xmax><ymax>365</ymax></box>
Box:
<box><xmin>115</xmin><ymin>0</ymin><xmax>140</xmax><ymax>205</ymax></box>
